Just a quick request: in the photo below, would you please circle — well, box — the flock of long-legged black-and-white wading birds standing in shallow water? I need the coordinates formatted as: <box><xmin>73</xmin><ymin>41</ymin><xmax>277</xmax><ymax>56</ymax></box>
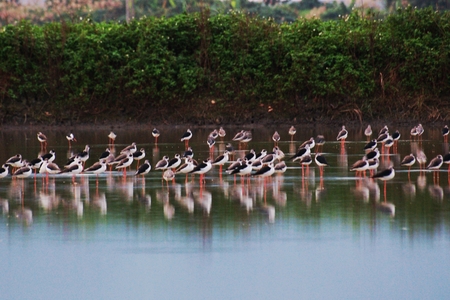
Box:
<box><xmin>0</xmin><ymin>124</ymin><xmax>450</xmax><ymax>192</ymax></box>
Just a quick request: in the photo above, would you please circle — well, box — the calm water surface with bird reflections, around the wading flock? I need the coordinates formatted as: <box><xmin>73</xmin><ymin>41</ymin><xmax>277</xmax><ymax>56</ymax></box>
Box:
<box><xmin>0</xmin><ymin>127</ymin><xmax>450</xmax><ymax>299</ymax></box>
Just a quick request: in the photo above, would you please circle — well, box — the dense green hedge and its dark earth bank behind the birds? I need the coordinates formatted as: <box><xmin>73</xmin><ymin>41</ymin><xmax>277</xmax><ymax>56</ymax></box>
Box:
<box><xmin>0</xmin><ymin>7</ymin><xmax>450</xmax><ymax>123</ymax></box>
